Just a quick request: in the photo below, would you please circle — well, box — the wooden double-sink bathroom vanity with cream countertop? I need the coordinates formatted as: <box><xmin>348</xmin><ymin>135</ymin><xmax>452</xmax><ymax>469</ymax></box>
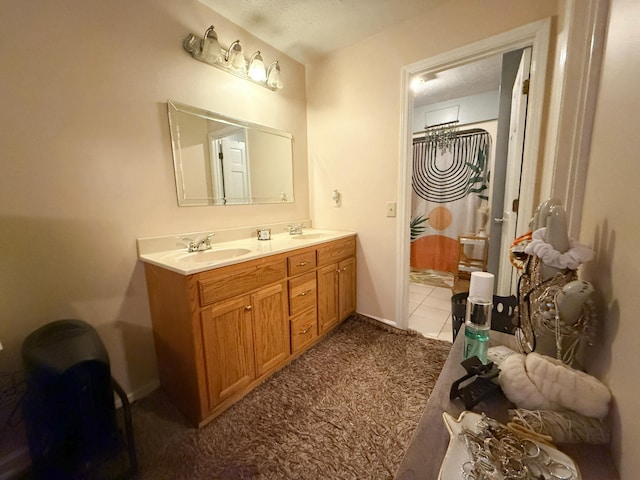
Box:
<box><xmin>138</xmin><ymin>230</ymin><xmax>356</xmax><ymax>426</ymax></box>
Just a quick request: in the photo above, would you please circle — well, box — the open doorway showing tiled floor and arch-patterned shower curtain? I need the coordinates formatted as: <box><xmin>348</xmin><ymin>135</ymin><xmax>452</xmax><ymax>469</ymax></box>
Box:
<box><xmin>408</xmin><ymin>47</ymin><xmax>531</xmax><ymax>340</ymax></box>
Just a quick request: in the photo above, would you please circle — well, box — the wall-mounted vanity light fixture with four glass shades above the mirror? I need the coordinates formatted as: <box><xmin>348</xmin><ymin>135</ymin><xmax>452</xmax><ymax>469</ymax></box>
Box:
<box><xmin>182</xmin><ymin>25</ymin><xmax>283</xmax><ymax>90</ymax></box>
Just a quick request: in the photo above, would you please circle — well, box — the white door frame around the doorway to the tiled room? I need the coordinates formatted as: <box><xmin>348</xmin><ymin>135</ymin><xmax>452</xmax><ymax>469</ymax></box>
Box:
<box><xmin>396</xmin><ymin>18</ymin><xmax>553</xmax><ymax>329</ymax></box>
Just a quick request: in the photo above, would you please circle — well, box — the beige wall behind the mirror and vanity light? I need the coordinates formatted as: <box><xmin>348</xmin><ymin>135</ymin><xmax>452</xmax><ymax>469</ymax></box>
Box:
<box><xmin>0</xmin><ymin>0</ymin><xmax>309</xmax><ymax>398</ymax></box>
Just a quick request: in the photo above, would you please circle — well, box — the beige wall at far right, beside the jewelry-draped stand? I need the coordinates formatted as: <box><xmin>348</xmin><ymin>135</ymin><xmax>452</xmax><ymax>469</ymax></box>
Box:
<box><xmin>580</xmin><ymin>0</ymin><xmax>640</xmax><ymax>480</ymax></box>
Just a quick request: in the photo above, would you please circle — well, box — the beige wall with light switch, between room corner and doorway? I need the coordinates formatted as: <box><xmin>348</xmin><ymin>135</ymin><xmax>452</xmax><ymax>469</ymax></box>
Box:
<box><xmin>307</xmin><ymin>0</ymin><xmax>558</xmax><ymax>322</ymax></box>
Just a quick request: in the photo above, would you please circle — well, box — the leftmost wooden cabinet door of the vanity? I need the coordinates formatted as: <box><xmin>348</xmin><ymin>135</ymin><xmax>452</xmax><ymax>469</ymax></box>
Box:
<box><xmin>200</xmin><ymin>295</ymin><xmax>256</xmax><ymax>409</ymax></box>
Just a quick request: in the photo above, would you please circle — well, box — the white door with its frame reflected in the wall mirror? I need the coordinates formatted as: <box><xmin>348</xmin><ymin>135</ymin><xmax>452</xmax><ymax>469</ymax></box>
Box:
<box><xmin>209</xmin><ymin>130</ymin><xmax>251</xmax><ymax>205</ymax></box>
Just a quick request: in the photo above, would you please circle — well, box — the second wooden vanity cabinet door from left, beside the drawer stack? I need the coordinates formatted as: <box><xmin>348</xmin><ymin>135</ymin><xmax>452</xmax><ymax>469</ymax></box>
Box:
<box><xmin>251</xmin><ymin>283</ymin><xmax>291</xmax><ymax>377</ymax></box>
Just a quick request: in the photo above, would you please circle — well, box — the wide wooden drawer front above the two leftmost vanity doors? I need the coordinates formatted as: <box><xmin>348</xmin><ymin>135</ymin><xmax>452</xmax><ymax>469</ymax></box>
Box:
<box><xmin>199</xmin><ymin>258</ymin><xmax>286</xmax><ymax>306</ymax></box>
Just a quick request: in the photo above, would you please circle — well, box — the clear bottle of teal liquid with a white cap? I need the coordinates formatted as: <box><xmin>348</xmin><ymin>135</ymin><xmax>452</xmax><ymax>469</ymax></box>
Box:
<box><xmin>463</xmin><ymin>272</ymin><xmax>493</xmax><ymax>364</ymax></box>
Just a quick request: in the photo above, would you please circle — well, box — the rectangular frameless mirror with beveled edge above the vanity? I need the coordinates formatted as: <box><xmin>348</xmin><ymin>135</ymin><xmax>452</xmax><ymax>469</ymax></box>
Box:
<box><xmin>167</xmin><ymin>100</ymin><xmax>293</xmax><ymax>206</ymax></box>
